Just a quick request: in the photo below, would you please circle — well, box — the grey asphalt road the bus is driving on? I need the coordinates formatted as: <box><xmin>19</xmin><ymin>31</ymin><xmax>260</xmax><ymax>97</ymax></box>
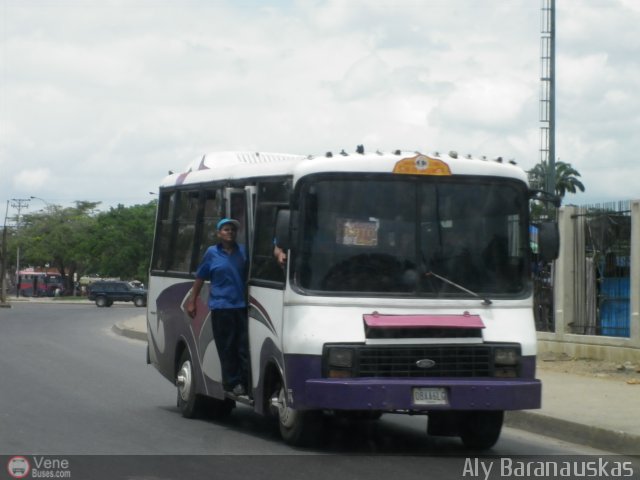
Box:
<box><xmin>0</xmin><ymin>302</ymin><xmax>620</xmax><ymax>480</ymax></box>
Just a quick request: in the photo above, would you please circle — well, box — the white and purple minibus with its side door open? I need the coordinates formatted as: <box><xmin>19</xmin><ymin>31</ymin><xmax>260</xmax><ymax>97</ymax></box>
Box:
<box><xmin>147</xmin><ymin>150</ymin><xmax>558</xmax><ymax>448</ymax></box>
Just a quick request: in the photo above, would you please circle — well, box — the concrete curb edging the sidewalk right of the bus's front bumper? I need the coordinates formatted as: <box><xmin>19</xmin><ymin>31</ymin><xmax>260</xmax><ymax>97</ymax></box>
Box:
<box><xmin>505</xmin><ymin>411</ymin><xmax>640</xmax><ymax>455</ymax></box>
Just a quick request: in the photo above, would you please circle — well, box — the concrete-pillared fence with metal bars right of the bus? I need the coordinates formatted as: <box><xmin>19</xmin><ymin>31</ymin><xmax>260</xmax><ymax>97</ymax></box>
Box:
<box><xmin>534</xmin><ymin>201</ymin><xmax>640</xmax><ymax>360</ymax></box>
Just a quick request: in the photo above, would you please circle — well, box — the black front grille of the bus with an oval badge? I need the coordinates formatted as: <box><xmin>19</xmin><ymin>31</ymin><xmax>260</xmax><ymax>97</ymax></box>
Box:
<box><xmin>356</xmin><ymin>345</ymin><xmax>492</xmax><ymax>377</ymax></box>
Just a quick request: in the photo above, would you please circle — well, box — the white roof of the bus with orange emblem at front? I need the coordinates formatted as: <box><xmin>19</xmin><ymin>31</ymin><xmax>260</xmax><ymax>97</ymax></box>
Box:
<box><xmin>160</xmin><ymin>151</ymin><xmax>528</xmax><ymax>187</ymax></box>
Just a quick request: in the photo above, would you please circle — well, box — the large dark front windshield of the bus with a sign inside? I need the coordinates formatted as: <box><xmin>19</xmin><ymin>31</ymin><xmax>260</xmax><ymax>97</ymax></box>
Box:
<box><xmin>292</xmin><ymin>175</ymin><xmax>530</xmax><ymax>298</ymax></box>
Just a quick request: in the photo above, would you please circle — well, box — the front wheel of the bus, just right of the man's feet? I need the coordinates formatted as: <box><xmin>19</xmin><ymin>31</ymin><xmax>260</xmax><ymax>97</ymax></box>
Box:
<box><xmin>276</xmin><ymin>382</ymin><xmax>324</xmax><ymax>447</ymax></box>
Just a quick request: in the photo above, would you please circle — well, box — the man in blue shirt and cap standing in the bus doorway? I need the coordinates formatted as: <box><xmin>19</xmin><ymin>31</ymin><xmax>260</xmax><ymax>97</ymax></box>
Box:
<box><xmin>187</xmin><ymin>218</ymin><xmax>248</xmax><ymax>395</ymax></box>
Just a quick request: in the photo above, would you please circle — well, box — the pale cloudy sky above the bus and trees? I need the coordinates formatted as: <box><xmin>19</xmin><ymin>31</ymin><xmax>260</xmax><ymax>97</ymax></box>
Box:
<box><xmin>0</xmin><ymin>0</ymin><xmax>640</xmax><ymax>216</ymax></box>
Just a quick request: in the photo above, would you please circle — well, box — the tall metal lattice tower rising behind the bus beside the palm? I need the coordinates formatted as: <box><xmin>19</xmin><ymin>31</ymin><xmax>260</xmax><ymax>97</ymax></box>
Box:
<box><xmin>540</xmin><ymin>0</ymin><xmax>556</xmax><ymax>194</ymax></box>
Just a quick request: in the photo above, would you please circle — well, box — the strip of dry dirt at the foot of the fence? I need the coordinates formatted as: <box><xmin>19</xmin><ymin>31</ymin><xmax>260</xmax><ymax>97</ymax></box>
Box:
<box><xmin>538</xmin><ymin>353</ymin><xmax>640</xmax><ymax>382</ymax></box>
